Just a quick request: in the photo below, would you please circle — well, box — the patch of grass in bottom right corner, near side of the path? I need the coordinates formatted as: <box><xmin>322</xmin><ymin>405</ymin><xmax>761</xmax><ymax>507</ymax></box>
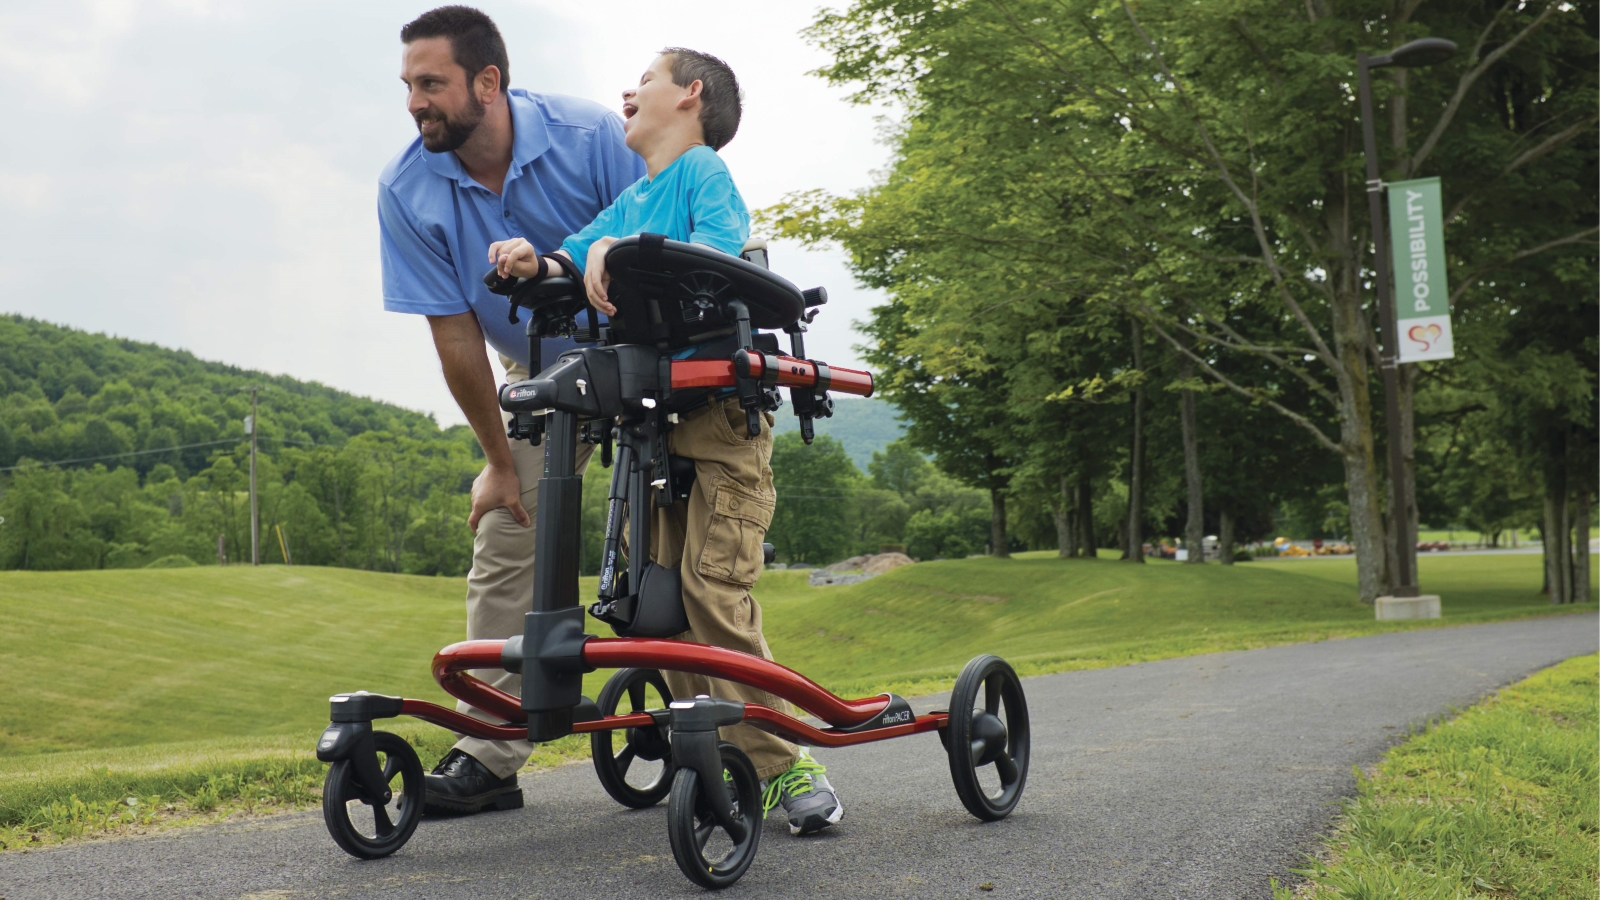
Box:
<box><xmin>1274</xmin><ymin>655</ymin><xmax>1600</xmax><ymax>900</ymax></box>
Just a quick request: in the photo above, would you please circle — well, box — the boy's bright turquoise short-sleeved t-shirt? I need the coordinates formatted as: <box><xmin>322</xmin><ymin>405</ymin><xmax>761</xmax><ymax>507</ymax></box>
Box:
<box><xmin>562</xmin><ymin>144</ymin><xmax>750</xmax><ymax>269</ymax></box>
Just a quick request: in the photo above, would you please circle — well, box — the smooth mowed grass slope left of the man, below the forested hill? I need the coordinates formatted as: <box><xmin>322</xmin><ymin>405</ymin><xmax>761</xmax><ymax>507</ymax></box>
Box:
<box><xmin>0</xmin><ymin>567</ymin><xmax>464</xmax><ymax>756</ymax></box>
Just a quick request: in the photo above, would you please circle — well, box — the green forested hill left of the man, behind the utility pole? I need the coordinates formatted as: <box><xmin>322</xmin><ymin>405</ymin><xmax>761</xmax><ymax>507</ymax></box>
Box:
<box><xmin>0</xmin><ymin>315</ymin><xmax>478</xmax><ymax>575</ymax></box>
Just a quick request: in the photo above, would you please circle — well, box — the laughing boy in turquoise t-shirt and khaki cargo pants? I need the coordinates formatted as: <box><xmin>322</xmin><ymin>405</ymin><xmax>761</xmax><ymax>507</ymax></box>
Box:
<box><xmin>490</xmin><ymin>48</ymin><xmax>845</xmax><ymax>834</ymax></box>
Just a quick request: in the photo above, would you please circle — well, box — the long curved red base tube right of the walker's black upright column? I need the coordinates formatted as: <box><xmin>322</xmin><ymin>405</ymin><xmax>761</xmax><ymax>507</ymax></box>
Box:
<box><xmin>584</xmin><ymin>637</ymin><xmax>888</xmax><ymax>729</ymax></box>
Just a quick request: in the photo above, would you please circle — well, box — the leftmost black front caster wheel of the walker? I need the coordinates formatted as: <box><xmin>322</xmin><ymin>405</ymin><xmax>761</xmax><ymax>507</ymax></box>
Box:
<box><xmin>322</xmin><ymin>732</ymin><xmax>426</xmax><ymax>860</ymax></box>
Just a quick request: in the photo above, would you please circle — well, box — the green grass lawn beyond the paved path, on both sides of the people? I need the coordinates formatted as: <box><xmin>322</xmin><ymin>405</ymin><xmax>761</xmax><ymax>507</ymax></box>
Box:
<box><xmin>0</xmin><ymin>554</ymin><xmax>1594</xmax><ymax>841</ymax></box>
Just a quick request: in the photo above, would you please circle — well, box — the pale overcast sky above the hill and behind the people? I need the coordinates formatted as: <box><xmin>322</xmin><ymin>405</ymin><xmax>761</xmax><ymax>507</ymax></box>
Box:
<box><xmin>0</xmin><ymin>0</ymin><xmax>888</xmax><ymax>424</ymax></box>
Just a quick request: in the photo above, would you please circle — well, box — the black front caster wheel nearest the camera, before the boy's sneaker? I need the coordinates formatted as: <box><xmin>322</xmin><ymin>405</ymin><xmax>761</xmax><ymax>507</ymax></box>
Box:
<box><xmin>667</xmin><ymin>741</ymin><xmax>763</xmax><ymax>890</ymax></box>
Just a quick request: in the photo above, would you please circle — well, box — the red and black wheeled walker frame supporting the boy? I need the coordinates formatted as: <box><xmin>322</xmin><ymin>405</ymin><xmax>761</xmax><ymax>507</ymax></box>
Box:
<box><xmin>317</xmin><ymin>239</ymin><xmax>1029</xmax><ymax>889</ymax></box>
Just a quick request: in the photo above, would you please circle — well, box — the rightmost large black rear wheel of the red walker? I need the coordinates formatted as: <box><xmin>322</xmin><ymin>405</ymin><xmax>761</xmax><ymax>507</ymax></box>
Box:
<box><xmin>941</xmin><ymin>655</ymin><xmax>1029</xmax><ymax>822</ymax></box>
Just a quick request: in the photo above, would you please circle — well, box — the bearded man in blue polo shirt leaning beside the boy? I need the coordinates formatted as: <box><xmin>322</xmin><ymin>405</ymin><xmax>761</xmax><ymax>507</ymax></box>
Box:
<box><xmin>378</xmin><ymin>6</ymin><xmax>645</xmax><ymax>814</ymax></box>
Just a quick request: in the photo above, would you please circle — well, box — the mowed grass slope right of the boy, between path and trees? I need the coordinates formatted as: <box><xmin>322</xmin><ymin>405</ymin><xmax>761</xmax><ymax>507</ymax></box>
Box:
<box><xmin>757</xmin><ymin>552</ymin><xmax>1594</xmax><ymax>693</ymax></box>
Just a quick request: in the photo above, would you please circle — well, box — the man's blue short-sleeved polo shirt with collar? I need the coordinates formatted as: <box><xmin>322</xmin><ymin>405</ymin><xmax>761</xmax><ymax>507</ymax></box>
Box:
<box><xmin>378</xmin><ymin>88</ymin><xmax>645</xmax><ymax>365</ymax></box>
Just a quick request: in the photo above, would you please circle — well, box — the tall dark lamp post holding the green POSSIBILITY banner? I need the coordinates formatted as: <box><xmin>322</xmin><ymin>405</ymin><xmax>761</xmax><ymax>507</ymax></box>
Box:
<box><xmin>1355</xmin><ymin>37</ymin><xmax>1456</xmax><ymax>597</ymax></box>
